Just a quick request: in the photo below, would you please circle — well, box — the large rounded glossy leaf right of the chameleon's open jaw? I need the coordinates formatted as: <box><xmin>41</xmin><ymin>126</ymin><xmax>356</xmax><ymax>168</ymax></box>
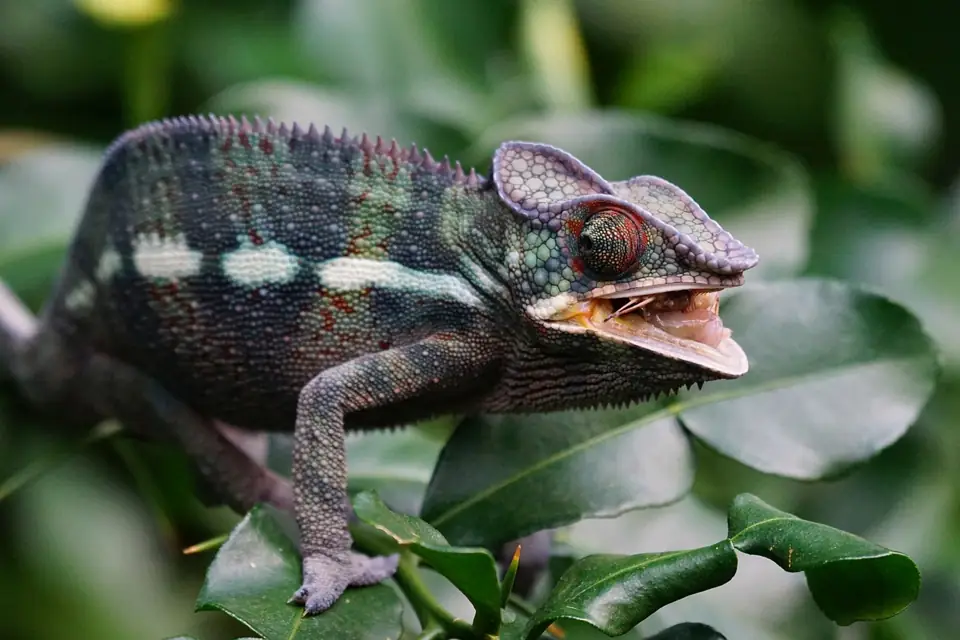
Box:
<box><xmin>674</xmin><ymin>280</ymin><xmax>938</xmax><ymax>479</ymax></box>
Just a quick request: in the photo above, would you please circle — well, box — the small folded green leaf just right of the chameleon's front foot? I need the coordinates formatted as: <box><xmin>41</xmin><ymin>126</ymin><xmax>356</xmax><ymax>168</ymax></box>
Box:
<box><xmin>353</xmin><ymin>491</ymin><xmax>500</xmax><ymax>621</ymax></box>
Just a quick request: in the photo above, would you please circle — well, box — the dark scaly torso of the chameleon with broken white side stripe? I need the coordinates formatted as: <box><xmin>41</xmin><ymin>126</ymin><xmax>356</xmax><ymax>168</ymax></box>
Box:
<box><xmin>48</xmin><ymin>118</ymin><xmax>498</xmax><ymax>429</ymax></box>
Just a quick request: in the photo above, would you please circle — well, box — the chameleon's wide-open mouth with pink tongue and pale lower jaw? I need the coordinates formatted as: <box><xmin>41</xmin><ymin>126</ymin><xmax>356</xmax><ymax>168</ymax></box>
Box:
<box><xmin>554</xmin><ymin>285</ymin><xmax>748</xmax><ymax>377</ymax></box>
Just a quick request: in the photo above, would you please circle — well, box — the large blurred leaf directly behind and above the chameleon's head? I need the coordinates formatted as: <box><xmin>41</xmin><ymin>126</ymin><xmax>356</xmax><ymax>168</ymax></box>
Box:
<box><xmin>469</xmin><ymin>110</ymin><xmax>813</xmax><ymax>281</ymax></box>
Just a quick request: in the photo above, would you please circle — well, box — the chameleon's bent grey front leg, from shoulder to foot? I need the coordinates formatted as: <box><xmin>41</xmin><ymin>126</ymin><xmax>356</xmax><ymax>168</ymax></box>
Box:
<box><xmin>291</xmin><ymin>334</ymin><xmax>494</xmax><ymax>615</ymax></box>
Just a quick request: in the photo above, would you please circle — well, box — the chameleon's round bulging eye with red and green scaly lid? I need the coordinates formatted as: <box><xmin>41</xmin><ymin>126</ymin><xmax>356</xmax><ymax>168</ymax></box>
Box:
<box><xmin>577</xmin><ymin>209</ymin><xmax>647</xmax><ymax>279</ymax></box>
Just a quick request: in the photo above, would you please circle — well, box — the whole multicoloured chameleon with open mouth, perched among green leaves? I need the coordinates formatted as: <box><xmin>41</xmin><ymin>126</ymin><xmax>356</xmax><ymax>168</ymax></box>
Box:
<box><xmin>0</xmin><ymin>115</ymin><xmax>759</xmax><ymax>615</ymax></box>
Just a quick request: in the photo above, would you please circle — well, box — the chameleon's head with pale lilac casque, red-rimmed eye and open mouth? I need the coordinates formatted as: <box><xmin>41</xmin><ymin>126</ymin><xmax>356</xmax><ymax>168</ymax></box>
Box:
<box><xmin>493</xmin><ymin>142</ymin><xmax>758</xmax><ymax>382</ymax></box>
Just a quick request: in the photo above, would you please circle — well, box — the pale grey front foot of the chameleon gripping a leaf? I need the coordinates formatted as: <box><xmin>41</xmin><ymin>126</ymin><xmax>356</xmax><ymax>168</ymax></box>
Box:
<box><xmin>290</xmin><ymin>551</ymin><xmax>400</xmax><ymax>616</ymax></box>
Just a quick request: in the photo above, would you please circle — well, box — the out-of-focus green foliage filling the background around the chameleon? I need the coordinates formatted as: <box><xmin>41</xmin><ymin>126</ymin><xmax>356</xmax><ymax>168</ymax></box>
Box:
<box><xmin>0</xmin><ymin>0</ymin><xmax>960</xmax><ymax>640</ymax></box>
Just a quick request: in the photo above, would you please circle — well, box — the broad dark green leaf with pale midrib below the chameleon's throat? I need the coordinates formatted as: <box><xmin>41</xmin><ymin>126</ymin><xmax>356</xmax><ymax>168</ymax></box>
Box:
<box><xmin>422</xmin><ymin>404</ymin><xmax>693</xmax><ymax>546</ymax></box>
